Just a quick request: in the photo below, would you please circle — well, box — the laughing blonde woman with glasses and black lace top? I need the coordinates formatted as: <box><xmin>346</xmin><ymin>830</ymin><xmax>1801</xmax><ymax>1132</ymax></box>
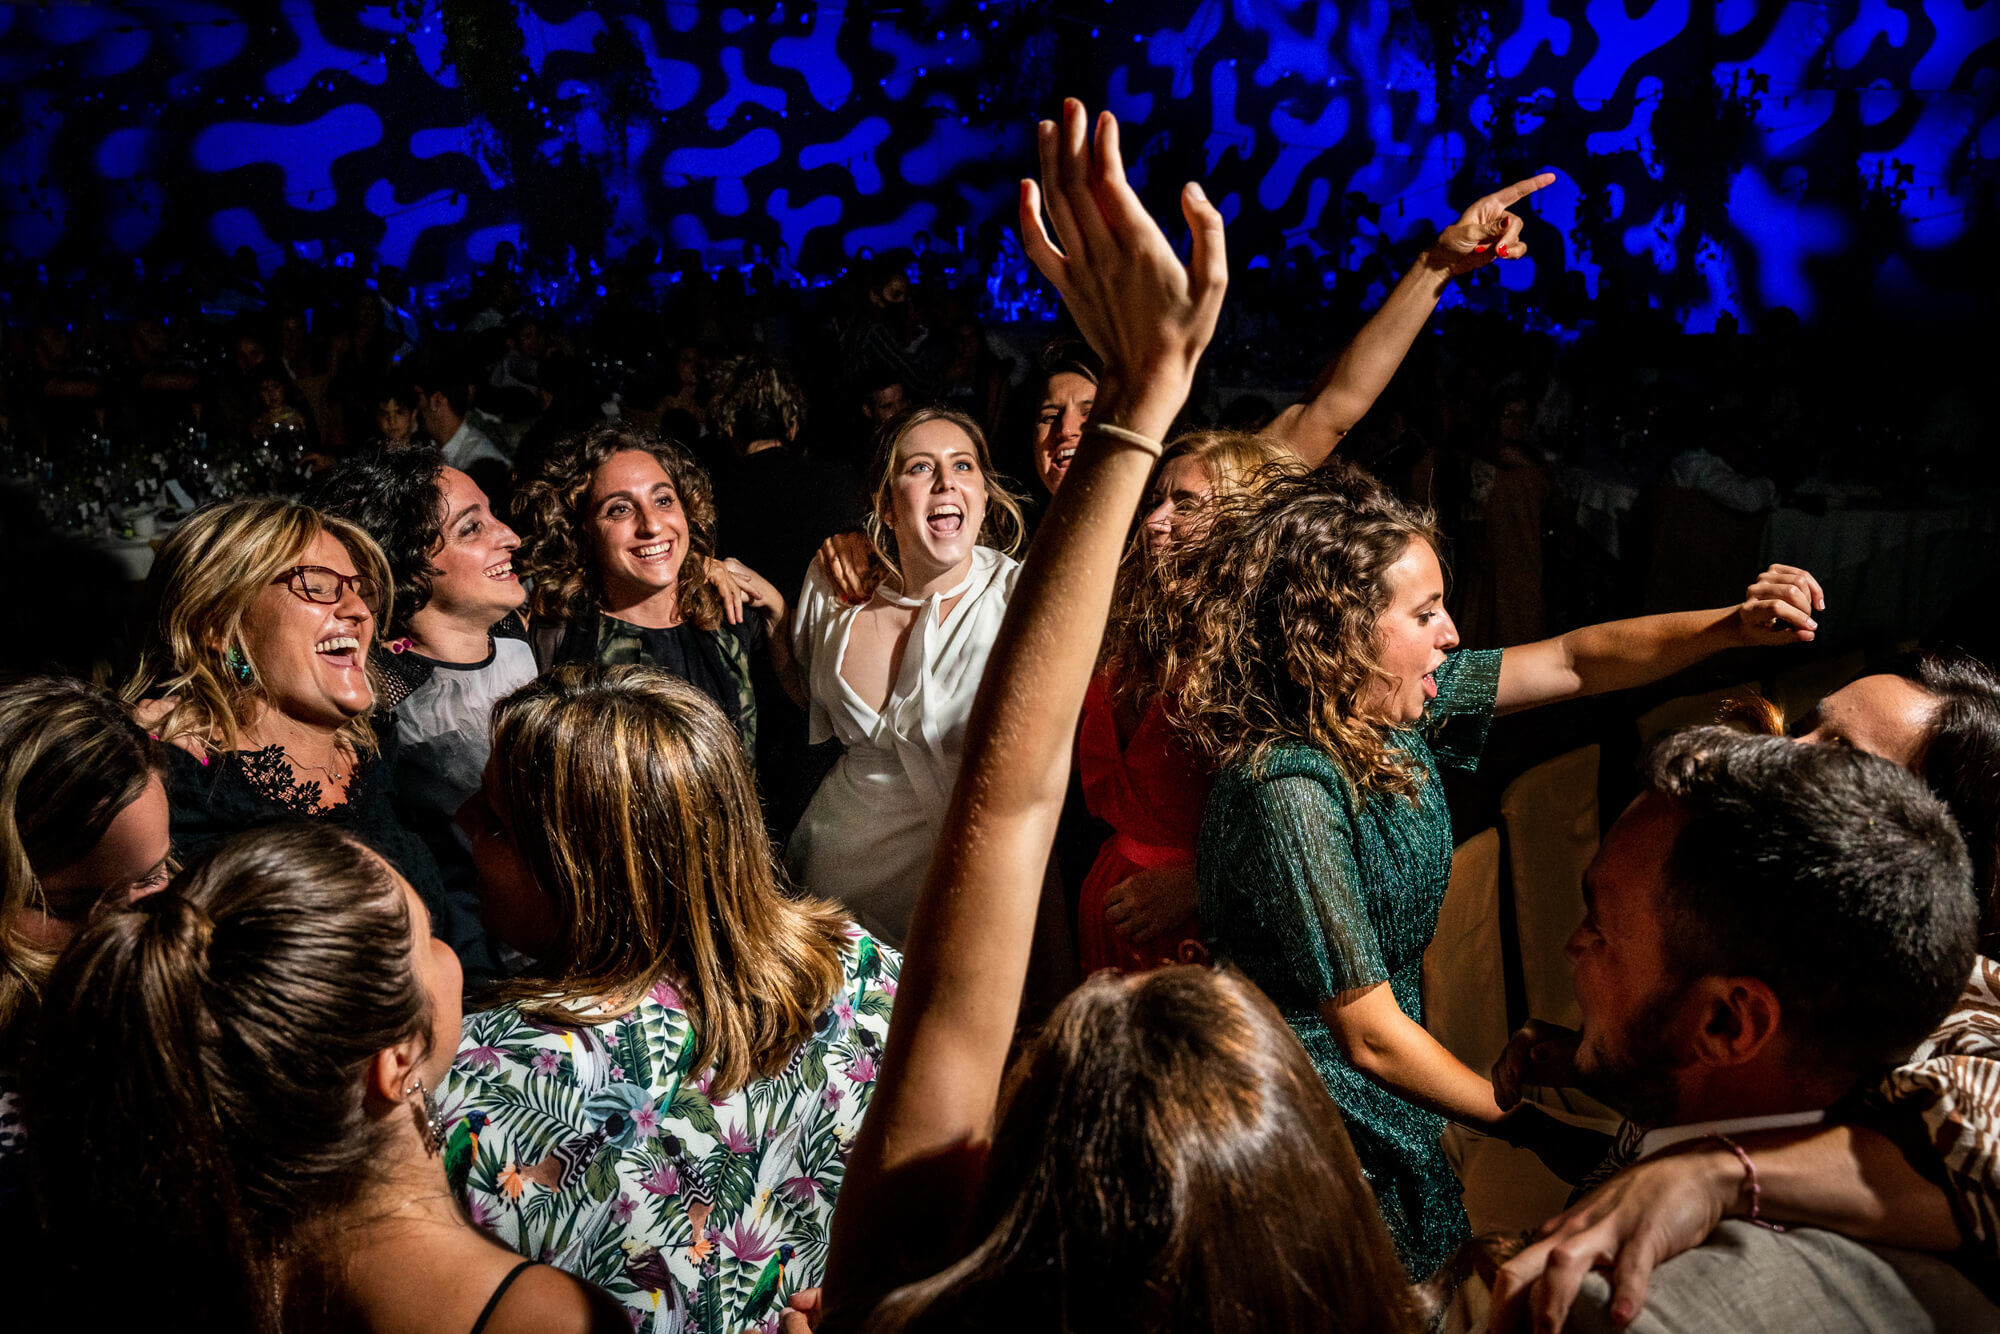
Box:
<box><xmin>124</xmin><ymin>500</ymin><xmax>450</xmax><ymax>920</ymax></box>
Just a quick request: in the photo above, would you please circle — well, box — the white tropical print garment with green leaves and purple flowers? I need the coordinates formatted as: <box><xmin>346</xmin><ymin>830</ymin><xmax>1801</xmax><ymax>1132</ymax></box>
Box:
<box><xmin>440</xmin><ymin>928</ymin><xmax>902</xmax><ymax>1334</ymax></box>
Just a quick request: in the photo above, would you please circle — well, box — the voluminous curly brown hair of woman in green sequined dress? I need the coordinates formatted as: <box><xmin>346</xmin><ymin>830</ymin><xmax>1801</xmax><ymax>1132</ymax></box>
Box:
<box><xmin>1106</xmin><ymin>466</ymin><xmax>1438</xmax><ymax>796</ymax></box>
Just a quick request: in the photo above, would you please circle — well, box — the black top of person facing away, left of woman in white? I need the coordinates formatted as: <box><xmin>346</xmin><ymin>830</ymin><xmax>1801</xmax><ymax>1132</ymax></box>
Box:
<box><xmin>714</xmin><ymin>448</ymin><xmax>868</xmax><ymax>604</ymax></box>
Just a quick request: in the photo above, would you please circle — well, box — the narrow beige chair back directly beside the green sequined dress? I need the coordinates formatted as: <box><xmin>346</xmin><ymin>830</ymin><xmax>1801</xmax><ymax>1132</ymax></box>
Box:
<box><xmin>1424</xmin><ymin>830</ymin><xmax>1508</xmax><ymax>1072</ymax></box>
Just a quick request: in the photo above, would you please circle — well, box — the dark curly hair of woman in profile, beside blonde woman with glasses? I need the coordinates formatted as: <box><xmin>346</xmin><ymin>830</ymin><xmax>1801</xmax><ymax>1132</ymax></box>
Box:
<box><xmin>304</xmin><ymin>444</ymin><xmax>444</xmax><ymax>638</ymax></box>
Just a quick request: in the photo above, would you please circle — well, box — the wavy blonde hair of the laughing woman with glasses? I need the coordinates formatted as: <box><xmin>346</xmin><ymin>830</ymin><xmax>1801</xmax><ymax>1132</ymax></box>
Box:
<box><xmin>122</xmin><ymin>498</ymin><xmax>394</xmax><ymax>756</ymax></box>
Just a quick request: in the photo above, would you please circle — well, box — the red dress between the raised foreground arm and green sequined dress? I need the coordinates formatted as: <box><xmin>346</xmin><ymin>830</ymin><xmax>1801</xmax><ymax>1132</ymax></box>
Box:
<box><xmin>1076</xmin><ymin>674</ymin><xmax>1214</xmax><ymax>974</ymax></box>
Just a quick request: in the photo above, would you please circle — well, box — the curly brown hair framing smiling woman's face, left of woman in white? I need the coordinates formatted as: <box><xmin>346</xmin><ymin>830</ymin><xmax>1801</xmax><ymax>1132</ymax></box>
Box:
<box><xmin>514</xmin><ymin>426</ymin><xmax>722</xmax><ymax>630</ymax></box>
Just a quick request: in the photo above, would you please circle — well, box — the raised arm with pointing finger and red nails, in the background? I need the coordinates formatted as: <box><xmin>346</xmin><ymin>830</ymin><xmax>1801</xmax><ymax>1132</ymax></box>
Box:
<box><xmin>1264</xmin><ymin>172</ymin><xmax>1556</xmax><ymax>468</ymax></box>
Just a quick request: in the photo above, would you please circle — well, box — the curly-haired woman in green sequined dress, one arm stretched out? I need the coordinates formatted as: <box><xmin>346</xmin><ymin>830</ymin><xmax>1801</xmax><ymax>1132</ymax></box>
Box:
<box><xmin>1156</xmin><ymin>472</ymin><xmax>1818</xmax><ymax>1278</ymax></box>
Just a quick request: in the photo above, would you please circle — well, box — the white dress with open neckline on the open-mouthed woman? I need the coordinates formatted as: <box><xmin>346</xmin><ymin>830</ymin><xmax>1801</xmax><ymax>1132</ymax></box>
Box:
<box><xmin>784</xmin><ymin>546</ymin><xmax>1020</xmax><ymax>950</ymax></box>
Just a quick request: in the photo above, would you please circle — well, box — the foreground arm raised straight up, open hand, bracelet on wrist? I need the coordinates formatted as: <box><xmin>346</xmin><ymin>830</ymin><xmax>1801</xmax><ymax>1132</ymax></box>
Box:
<box><xmin>826</xmin><ymin>102</ymin><xmax>1228</xmax><ymax>1320</ymax></box>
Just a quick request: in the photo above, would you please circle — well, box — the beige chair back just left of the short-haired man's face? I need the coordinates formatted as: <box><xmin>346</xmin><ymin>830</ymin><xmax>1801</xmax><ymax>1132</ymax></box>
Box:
<box><xmin>1500</xmin><ymin>746</ymin><xmax>1598</xmax><ymax>1028</ymax></box>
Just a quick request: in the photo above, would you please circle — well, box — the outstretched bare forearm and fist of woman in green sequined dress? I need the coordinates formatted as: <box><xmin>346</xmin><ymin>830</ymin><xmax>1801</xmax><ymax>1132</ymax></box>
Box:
<box><xmin>1494</xmin><ymin>566</ymin><xmax>1826</xmax><ymax>714</ymax></box>
